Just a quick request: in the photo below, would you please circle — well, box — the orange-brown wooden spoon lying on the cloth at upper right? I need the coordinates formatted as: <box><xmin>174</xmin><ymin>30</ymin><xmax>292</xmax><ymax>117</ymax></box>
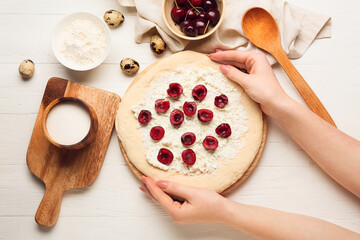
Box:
<box><xmin>242</xmin><ymin>7</ymin><xmax>336</xmax><ymax>127</ymax></box>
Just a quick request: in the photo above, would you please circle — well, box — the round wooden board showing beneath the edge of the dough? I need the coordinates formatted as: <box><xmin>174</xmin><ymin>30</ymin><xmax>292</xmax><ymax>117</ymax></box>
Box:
<box><xmin>118</xmin><ymin>56</ymin><xmax>267</xmax><ymax>195</ymax></box>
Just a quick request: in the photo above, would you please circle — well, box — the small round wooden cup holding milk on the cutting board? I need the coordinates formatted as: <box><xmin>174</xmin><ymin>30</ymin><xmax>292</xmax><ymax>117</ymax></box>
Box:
<box><xmin>41</xmin><ymin>97</ymin><xmax>98</xmax><ymax>150</ymax></box>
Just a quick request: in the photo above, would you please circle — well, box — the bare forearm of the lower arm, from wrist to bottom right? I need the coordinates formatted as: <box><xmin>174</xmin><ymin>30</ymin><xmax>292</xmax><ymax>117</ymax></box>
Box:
<box><xmin>222</xmin><ymin>200</ymin><xmax>360</xmax><ymax>240</ymax></box>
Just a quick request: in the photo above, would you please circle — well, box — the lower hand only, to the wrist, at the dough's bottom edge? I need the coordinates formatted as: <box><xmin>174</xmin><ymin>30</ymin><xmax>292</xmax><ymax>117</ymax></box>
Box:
<box><xmin>140</xmin><ymin>177</ymin><xmax>229</xmax><ymax>224</ymax></box>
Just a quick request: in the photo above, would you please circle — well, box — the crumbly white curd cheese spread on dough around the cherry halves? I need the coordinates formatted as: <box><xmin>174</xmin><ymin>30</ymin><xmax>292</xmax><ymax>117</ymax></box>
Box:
<box><xmin>132</xmin><ymin>67</ymin><xmax>248</xmax><ymax>175</ymax></box>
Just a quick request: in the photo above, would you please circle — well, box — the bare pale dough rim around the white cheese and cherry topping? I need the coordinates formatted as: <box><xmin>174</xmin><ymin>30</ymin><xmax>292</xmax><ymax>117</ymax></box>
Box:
<box><xmin>115</xmin><ymin>51</ymin><xmax>263</xmax><ymax>192</ymax></box>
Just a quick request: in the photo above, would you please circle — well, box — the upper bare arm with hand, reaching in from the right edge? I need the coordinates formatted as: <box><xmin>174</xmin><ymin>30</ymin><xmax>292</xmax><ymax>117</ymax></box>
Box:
<box><xmin>209</xmin><ymin>51</ymin><xmax>360</xmax><ymax>197</ymax></box>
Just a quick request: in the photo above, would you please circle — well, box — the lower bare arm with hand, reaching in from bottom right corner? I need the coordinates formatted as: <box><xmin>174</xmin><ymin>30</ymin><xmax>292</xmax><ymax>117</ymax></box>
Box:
<box><xmin>140</xmin><ymin>177</ymin><xmax>360</xmax><ymax>240</ymax></box>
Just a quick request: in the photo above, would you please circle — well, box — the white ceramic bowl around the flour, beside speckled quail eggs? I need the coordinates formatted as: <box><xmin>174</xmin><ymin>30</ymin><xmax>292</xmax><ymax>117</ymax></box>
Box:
<box><xmin>51</xmin><ymin>12</ymin><xmax>111</xmax><ymax>71</ymax></box>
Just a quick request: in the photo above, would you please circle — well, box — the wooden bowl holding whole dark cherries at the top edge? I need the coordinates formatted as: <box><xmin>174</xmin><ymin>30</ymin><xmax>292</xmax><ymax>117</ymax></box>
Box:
<box><xmin>162</xmin><ymin>0</ymin><xmax>225</xmax><ymax>40</ymax></box>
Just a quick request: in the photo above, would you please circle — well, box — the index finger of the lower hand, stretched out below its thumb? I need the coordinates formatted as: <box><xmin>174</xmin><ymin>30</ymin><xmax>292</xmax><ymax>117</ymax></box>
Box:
<box><xmin>141</xmin><ymin>177</ymin><xmax>175</xmax><ymax>212</ymax></box>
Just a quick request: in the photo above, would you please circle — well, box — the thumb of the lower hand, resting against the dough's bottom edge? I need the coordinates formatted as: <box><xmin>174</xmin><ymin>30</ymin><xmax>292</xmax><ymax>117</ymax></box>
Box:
<box><xmin>156</xmin><ymin>180</ymin><xmax>196</xmax><ymax>200</ymax></box>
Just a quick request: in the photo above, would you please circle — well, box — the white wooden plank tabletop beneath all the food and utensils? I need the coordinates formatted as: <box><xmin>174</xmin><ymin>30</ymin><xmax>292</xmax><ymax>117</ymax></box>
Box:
<box><xmin>0</xmin><ymin>0</ymin><xmax>360</xmax><ymax>239</ymax></box>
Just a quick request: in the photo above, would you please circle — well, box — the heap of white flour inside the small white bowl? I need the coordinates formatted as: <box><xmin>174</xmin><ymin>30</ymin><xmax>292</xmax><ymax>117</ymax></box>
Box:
<box><xmin>58</xmin><ymin>18</ymin><xmax>106</xmax><ymax>66</ymax></box>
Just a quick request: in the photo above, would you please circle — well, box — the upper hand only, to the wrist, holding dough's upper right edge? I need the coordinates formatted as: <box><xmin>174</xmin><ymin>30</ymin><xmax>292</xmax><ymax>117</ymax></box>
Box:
<box><xmin>209</xmin><ymin>50</ymin><xmax>290</xmax><ymax>116</ymax></box>
